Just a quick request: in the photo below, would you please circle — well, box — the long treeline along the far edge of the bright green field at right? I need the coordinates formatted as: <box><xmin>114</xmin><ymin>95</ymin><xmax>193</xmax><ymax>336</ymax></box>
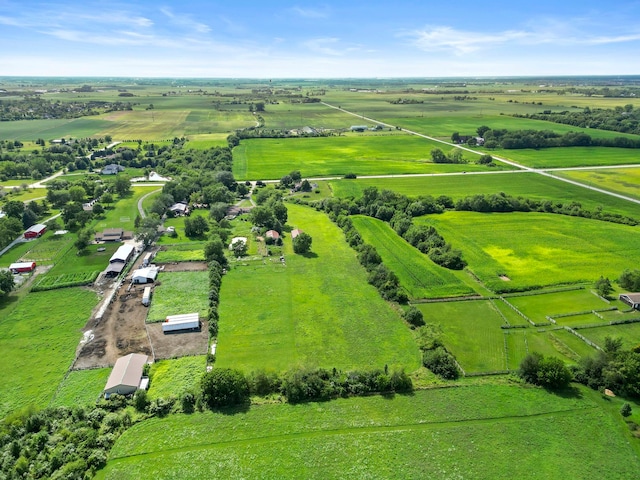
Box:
<box><xmin>454</xmin><ymin>192</ymin><xmax>640</xmax><ymax>225</ymax></box>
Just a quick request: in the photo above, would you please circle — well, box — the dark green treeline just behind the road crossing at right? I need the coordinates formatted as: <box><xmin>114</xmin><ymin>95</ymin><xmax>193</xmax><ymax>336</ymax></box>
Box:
<box><xmin>484</xmin><ymin>129</ymin><xmax>640</xmax><ymax>150</ymax></box>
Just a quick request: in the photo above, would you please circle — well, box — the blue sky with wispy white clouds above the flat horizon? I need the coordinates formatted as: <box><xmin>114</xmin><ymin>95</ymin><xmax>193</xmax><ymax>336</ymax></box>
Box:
<box><xmin>0</xmin><ymin>0</ymin><xmax>640</xmax><ymax>78</ymax></box>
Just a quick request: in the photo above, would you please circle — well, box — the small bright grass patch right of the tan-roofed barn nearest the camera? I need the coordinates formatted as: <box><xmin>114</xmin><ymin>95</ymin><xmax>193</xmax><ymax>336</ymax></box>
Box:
<box><xmin>149</xmin><ymin>355</ymin><xmax>207</xmax><ymax>398</ymax></box>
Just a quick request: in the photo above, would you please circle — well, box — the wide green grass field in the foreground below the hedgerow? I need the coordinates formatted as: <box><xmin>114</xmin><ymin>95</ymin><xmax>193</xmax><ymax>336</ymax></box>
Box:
<box><xmin>97</xmin><ymin>385</ymin><xmax>640</xmax><ymax>480</ymax></box>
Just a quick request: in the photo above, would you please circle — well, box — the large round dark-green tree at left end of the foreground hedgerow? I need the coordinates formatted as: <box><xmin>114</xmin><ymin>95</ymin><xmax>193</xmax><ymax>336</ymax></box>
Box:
<box><xmin>200</xmin><ymin>368</ymin><xmax>249</xmax><ymax>410</ymax></box>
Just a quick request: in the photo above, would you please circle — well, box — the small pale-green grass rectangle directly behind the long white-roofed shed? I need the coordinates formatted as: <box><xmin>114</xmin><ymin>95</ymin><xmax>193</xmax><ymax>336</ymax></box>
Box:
<box><xmin>147</xmin><ymin>272</ymin><xmax>209</xmax><ymax>322</ymax></box>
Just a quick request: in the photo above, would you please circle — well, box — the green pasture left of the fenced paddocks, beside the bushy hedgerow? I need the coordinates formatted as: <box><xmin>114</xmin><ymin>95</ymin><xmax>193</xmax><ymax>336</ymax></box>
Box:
<box><xmin>416</xmin><ymin>300</ymin><xmax>507</xmax><ymax>373</ymax></box>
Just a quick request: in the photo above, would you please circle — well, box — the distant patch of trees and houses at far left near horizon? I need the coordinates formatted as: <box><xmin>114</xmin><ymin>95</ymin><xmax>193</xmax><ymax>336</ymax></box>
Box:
<box><xmin>0</xmin><ymin>95</ymin><xmax>133</xmax><ymax>122</ymax></box>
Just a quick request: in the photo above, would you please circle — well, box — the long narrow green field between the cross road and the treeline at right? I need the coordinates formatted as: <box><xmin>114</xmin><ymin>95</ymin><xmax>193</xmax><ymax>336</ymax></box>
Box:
<box><xmin>329</xmin><ymin>172</ymin><xmax>640</xmax><ymax>218</ymax></box>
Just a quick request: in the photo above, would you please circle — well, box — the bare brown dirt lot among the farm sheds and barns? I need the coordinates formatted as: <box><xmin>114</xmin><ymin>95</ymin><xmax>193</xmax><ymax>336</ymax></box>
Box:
<box><xmin>74</xmin><ymin>259</ymin><xmax>209</xmax><ymax>369</ymax></box>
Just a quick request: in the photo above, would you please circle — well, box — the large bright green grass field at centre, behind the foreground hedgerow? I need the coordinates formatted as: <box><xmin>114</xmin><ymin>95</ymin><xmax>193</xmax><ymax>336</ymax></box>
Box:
<box><xmin>216</xmin><ymin>204</ymin><xmax>420</xmax><ymax>372</ymax></box>
